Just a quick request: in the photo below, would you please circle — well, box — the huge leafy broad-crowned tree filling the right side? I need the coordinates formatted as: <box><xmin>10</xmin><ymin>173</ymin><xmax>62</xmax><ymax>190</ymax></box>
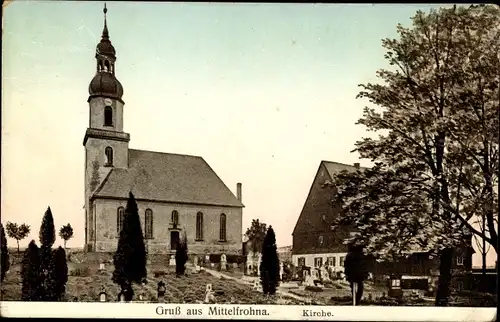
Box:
<box><xmin>326</xmin><ymin>6</ymin><xmax>500</xmax><ymax>305</ymax></box>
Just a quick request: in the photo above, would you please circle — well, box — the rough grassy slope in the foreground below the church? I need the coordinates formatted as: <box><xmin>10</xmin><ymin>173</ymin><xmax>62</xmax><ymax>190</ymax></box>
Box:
<box><xmin>1</xmin><ymin>263</ymin><xmax>299</xmax><ymax>304</ymax></box>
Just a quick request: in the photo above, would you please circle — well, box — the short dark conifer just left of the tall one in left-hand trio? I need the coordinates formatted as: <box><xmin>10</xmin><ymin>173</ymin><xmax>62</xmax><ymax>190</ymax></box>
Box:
<box><xmin>21</xmin><ymin>240</ymin><xmax>43</xmax><ymax>301</ymax></box>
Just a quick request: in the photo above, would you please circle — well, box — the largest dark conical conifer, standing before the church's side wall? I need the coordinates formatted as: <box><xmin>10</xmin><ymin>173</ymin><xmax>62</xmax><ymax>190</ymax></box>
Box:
<box><xmin>113</xmin><ymin>192</ymin><xmax>147</xmax><ymax>301</ymax></box>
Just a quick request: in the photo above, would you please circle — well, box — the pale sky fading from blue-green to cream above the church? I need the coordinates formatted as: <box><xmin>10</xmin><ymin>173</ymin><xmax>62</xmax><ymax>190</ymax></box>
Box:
<box><xmin>1</xmin><ymin>1</ymin><xmax>496</xmax><ymax>265</ymax></box>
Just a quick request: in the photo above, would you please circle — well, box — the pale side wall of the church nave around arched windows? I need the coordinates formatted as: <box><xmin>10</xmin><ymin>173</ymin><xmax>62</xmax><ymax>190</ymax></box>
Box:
<box><xmin>95</xmin><ymin>199</ymin><xmax>242</xmax><ymax>254</ymax></box>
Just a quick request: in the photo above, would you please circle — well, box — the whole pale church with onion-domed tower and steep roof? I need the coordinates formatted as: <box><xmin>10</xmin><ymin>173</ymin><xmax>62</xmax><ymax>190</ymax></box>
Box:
<box><xmin>83</xmin><ymin>7</ymin><xmax>244</xmax><ymax>254</ymax></box>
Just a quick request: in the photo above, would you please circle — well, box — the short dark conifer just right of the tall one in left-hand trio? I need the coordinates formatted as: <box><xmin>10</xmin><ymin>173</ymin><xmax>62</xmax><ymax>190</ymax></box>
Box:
<box><xmin>46</xmin><ymin>246</ymin><xmax>68</xmax><ymax>301</ymax></box>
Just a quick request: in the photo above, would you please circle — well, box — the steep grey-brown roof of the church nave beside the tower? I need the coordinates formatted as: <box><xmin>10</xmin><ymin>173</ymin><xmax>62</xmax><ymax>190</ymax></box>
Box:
<box><xmin>93</xmin><ymin>149</ymin><xmax>244</xmax><ymax>207</ymax></box>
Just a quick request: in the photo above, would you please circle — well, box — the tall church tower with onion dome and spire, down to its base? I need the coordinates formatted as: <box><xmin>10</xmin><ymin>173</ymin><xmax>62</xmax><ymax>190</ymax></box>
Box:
<box><xmin>83</xmin><ymin>5</ymin><xmax>130</xmax><ymax>251</ymax></box>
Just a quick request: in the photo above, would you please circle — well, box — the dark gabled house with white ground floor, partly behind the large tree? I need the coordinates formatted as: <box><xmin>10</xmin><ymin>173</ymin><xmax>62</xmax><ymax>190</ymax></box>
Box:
<box><xmin>292</xmin><ymin>161</ymin><xmax>474</xmax><ymax>286</ymax></box>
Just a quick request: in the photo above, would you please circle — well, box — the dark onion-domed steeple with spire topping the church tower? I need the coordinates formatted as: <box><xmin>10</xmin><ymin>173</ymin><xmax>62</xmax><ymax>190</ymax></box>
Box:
<box><xmin>89</xmin><ymin>4</ymin><xmax>123</xmax><ymax>101</ymax></box>
